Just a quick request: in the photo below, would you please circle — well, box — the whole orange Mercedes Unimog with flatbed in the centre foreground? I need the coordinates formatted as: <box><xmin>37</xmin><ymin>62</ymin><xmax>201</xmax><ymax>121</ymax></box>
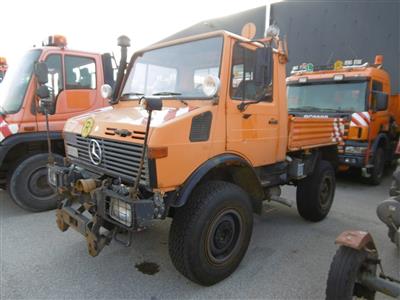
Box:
<box><xmin>48</xmin><ymin>30</ymin><xmax>337</xmax><ymax>285</ymax></box>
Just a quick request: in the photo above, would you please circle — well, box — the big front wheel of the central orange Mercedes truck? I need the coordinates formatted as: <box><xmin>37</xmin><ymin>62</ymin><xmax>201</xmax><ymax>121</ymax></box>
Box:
<box><xmin>169</xmin><ymin>181</ymin><xmax>253</xmax><ymax>286</ymax></box>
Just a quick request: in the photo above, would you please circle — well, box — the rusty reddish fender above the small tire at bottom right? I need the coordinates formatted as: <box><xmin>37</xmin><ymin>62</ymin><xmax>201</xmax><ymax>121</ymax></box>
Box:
<box><xmin>335</xmin><ymin>230</ymin><xmax>376</xmax><ymax>250</ymax></box>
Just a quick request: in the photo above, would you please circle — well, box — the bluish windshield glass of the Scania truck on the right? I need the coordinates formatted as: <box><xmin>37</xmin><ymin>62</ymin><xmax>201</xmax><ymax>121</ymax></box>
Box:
<box><xmin>288</xmin><ymin>82</ymin><xmax>367</xmax><ymax>112</ymax></box>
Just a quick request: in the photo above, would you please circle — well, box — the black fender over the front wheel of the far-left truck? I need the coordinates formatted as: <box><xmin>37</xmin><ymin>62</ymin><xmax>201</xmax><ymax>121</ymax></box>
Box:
<box><xmin>0</xmin><ymin>131</ymin><xmax>63</xmax><ymax>166</ymax></box>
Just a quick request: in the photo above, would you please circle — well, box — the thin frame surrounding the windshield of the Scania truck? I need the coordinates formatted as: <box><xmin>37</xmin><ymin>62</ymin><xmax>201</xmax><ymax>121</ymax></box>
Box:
<box><xmin>286</xmin><ymin>76</ymin><xmax>370</xmax><ymax>113</ymax></box>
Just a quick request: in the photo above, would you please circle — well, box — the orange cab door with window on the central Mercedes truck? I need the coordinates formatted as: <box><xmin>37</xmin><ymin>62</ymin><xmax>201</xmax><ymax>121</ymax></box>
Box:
<box><xmin>226</xmin><ymin>41</ymin><xmax>280</xmax><ymax>166</ymax></box>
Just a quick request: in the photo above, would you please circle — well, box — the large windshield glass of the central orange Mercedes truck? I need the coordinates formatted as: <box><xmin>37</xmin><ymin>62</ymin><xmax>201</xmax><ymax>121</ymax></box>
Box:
<box><xmin>122</xmin><ymin>37</ymin><xmax>223</xmax><ymax>99</ymax></box>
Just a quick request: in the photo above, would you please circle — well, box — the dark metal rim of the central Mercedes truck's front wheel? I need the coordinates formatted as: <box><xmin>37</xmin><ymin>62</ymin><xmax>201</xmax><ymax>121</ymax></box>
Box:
<box><xmin>206</xmin><ymin>209</ymin><xmax>243</xmax><ymax>265</ymax></box>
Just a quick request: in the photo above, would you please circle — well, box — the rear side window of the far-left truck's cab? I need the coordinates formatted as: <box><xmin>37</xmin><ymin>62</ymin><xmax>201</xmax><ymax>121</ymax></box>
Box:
<box><xmin>64</xmin><ymin>55</ymin><xmax>96</xmax><ymax>90</ymax></box>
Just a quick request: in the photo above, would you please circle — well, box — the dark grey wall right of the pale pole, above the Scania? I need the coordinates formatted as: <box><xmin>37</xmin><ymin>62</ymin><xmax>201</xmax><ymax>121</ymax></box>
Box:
<box><xmin>271</xmin><ymin>1</ymin><xmax>400</xmax><ymax>93</ymax></box>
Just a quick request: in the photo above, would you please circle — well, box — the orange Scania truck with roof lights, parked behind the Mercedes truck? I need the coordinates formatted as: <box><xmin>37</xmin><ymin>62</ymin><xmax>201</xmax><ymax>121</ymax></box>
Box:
<box><xmin>287</xmin><ymin>55</ymin><xmax>400</xmax><ymax>185</ymax></box>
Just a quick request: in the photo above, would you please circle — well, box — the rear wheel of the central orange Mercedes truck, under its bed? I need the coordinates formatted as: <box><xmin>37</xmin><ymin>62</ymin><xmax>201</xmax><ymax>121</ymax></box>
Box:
<box><xmin>296</xmin><ymin>160</ymin><xmax>336</xmax><ymax>222</ymax></box>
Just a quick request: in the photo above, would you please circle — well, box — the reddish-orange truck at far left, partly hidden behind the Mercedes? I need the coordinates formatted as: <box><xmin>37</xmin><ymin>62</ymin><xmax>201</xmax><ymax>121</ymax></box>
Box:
<box><xmin>0</xmin><ymin>35</ymin><xmax>128</xmax><ymax>211</ymax></box>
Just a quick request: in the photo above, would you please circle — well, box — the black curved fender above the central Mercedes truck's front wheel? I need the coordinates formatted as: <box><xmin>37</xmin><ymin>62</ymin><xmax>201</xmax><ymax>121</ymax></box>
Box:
<box><xmin>170</xmin><ymin>154</ymin><xmax>258</xmax><ymax>207</ymax></box>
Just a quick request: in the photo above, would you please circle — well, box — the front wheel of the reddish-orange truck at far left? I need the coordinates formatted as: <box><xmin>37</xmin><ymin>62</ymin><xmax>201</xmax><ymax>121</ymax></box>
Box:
<box><xmin>8</xmin><ymin>153</ymin><xmax>62</xmax><ymax>212</ymax></box>
